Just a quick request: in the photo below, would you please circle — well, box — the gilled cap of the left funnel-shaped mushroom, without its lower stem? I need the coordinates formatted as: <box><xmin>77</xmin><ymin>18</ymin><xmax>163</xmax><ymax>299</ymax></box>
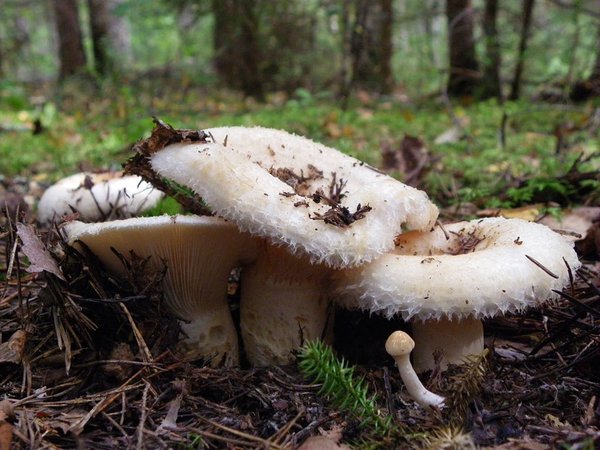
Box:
<box><xmin>63</xmin><ymin>215</ymin><xmax>257</xmax><ymax>320</ymax></box>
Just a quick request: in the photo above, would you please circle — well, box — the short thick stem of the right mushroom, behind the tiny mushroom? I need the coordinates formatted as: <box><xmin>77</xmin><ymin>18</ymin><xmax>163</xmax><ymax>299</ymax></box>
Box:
<box><xmin>411</xmin><ymin>317</ymin><xmax>483</xmax><ymax>373</ymax></box>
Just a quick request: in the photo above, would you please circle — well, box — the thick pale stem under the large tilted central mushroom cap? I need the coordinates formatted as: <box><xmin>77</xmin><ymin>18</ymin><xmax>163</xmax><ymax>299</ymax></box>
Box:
<box><xmin>240</xmin><ymin>242</ymin><xmax>333</xmax><ymax>366</ymax></box>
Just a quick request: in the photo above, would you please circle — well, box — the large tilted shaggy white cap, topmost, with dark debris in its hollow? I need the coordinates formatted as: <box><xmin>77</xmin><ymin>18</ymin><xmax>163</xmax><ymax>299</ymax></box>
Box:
<box><xmin>151</xmin><ymin>127</ymin><xmax>438</xmax><ymax>267</ymax></box>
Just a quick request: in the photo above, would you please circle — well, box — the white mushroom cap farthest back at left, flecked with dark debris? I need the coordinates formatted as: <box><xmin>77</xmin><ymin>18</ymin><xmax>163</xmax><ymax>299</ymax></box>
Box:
<box><xmin>37</xmin><ymin>172</ymin><xmax>163</xmax><ymax>224</ymax></box>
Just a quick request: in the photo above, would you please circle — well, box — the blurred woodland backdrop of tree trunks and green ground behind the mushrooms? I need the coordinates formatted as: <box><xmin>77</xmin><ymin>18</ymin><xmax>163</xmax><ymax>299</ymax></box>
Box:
<box><xmin>0</xmin><ymin>0</ymin><xmax>600</xmax><ymax>211</ymax></box>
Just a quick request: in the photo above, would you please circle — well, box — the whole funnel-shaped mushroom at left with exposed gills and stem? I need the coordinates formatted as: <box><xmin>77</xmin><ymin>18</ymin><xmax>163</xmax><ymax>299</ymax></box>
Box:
<box><xmin>64</xmin><ymin>216</ymin><xmax>257</xmax><ymax>366</ymax></box>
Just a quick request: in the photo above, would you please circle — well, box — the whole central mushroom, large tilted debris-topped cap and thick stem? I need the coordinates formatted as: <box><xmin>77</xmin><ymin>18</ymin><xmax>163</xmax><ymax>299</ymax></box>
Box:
<box><xmin>144</xmin><ymin>127</ymin><xmax>438</xmax><ymax>365</ymax></box>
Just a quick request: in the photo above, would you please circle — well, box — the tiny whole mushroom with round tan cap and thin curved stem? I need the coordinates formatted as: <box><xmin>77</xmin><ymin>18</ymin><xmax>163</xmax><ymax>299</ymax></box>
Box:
<box><xmin>385</xmin><ymin>331</ymin><xmax>444</xmax><ymax>408</ymax></box>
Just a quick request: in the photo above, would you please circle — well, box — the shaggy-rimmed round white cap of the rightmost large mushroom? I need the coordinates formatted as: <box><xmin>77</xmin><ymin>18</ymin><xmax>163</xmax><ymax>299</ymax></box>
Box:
<box><xmin>334</xmin><ymin>218</ymin><xmax>580</xmax><ymax>320</ymax></box>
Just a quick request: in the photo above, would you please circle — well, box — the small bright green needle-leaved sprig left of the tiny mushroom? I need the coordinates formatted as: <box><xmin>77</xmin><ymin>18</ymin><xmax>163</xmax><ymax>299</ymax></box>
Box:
<box><xmin>298</xmin><ymin>341</ymin><xmax>392</xmax><ymax>435</ymax></box>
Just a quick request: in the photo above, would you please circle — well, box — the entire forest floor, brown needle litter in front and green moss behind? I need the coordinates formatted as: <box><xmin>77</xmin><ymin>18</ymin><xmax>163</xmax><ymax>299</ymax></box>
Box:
<box><xmin>0</xmin><ymin>81</ymin><xmax>600</xmax><ymax>450</ymax></box>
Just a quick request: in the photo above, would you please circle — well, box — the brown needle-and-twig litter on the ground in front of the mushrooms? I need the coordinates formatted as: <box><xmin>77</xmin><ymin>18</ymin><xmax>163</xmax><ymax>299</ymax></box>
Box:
<box><xmin>0</xmin><ymin>176</ymin><xmax>600</xmax><ymax>450</ymax></box>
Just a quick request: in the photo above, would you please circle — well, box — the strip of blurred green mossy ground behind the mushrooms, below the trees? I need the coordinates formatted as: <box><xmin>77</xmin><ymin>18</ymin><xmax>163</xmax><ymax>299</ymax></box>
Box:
<box><xmin>0</xmin><ymin>76</ymin><xmax>600</xmax><ymax>208</ymax></box>
